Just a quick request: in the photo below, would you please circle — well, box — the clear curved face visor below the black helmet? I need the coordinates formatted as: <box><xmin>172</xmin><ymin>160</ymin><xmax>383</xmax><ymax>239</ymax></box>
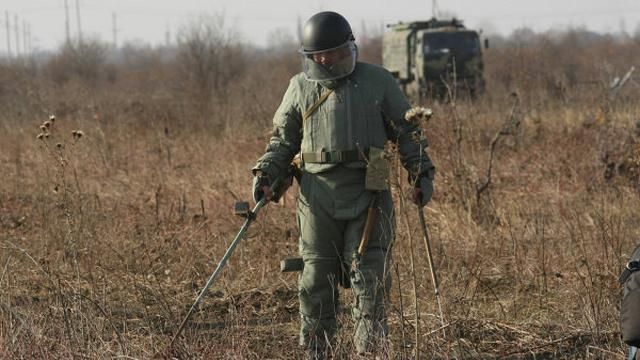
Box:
<box><xmin>300</xmin><ymin>40</ymin><xmax>357</xmax><ymax>81</ymax></box>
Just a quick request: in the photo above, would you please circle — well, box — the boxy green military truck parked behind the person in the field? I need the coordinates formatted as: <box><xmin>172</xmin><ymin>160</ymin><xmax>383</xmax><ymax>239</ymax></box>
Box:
<box><xmin>382</xmin><ymin>18</ymin><xmax>488</xmax><ymax>101</ymax></box>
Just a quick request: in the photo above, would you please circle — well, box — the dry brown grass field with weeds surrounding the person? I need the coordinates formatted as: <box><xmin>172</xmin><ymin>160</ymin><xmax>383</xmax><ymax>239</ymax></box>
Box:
<box><xmin>0</xmin><ymin>26</ymin><xmax>640</xmax><ymax>359</ymax></box>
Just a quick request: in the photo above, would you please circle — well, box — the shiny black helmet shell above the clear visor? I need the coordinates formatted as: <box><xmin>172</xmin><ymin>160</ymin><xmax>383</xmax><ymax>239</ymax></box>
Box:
<box><xmin>301</xmin><ymin>11</ymin><xmax>355</xmax><ymax>52</ymax></box>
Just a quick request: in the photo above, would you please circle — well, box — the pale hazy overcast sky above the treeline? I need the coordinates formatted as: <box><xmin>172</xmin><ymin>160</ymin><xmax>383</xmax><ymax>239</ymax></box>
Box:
<box><xmin>0</xmin><ymin>0</ymin><xmax>640</xmax><ymax>52</ymax></box>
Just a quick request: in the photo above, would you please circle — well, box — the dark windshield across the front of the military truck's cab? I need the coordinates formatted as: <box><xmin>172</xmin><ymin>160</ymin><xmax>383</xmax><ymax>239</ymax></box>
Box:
<box><xmin>423</xmin><ymin>32</ymin><xmax>480</xmax><ymax>54</ymax></box>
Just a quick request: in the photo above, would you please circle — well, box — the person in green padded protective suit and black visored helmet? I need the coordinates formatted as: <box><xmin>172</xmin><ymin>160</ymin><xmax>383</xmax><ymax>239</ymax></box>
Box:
<box><xmin>252</xmin><ymin>12</ymin><xmax>434</xmax><ymax>358</ymax></box>
